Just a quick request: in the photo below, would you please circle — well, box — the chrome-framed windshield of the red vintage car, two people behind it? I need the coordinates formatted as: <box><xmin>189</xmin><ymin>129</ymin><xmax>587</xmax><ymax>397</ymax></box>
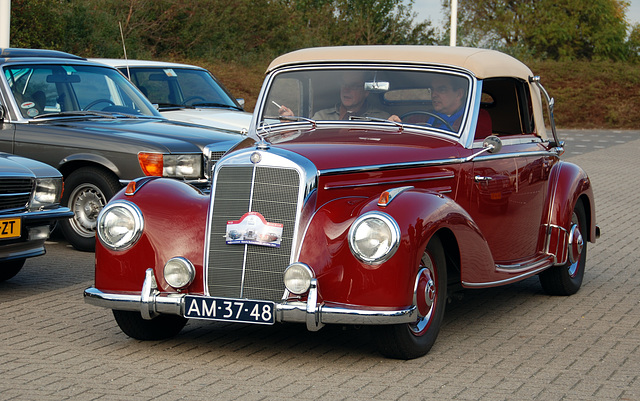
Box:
<box><xmin>260</xmin><ymin>68</ymin><xmax>471</xmax><ymax>134</ymax></box>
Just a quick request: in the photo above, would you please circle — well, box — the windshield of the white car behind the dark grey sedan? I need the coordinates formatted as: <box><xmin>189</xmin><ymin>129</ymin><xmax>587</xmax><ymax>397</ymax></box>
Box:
<box><xmin>122</xmin><ymin>67</ymin><xmax>241</xmax><ymax>109</ymax></box>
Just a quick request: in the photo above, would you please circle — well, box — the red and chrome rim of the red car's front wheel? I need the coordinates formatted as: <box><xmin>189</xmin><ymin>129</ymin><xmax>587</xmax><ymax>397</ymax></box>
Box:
<box><xmin>409</xmin><ymin>252</ymin><xmax>438</xmax><ymax>336</ymax></box>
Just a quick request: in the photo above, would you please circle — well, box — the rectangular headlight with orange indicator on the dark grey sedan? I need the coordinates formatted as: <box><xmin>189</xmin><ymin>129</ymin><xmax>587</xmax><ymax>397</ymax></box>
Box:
<box><xmin>138</xmin><ymin>152</ymin><xmax>202</xmax><ymax>179</ymax></box>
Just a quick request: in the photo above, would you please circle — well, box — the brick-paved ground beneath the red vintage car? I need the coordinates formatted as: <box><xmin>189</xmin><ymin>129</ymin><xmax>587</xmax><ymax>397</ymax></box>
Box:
<box><xmin>0</xmin><ymin>131</ymin><xmax>640</xmax><ymax>401</ymax></box>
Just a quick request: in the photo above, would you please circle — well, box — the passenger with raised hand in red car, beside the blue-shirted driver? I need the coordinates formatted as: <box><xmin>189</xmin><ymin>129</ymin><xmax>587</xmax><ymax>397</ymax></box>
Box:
<box><xmin>278</xmin><ymin>70</ymin><xmax>400</xmax><ymax>122</ymax></box>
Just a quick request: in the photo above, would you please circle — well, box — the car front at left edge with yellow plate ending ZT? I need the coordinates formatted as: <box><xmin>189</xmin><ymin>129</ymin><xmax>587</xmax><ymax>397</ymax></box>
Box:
<box><xmin>0</xmin><ymin>152</ymin><xmax>73</xmax><ymax>281</ymax></box>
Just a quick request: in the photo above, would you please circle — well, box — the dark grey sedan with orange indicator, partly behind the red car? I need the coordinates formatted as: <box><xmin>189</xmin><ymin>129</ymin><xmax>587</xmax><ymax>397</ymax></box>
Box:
<box><xmin>0</xmin><ymin>49</ymin><xmax>243</xmax><ymax>251</ymax></box>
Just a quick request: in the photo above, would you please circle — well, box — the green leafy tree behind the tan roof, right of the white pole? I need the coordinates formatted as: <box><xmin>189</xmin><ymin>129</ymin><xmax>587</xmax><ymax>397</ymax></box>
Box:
<box><xmin>443</xmin><ymin>0</ymin><xmax>629</xmax><ymax>60</ymax></box>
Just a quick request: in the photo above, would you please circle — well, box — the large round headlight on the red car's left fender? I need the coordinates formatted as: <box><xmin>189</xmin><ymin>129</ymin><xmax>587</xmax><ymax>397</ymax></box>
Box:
<box><xmin>97</xmin><ymin>200</ymin><xmax>144</xmax><ymax>250</ymax></box>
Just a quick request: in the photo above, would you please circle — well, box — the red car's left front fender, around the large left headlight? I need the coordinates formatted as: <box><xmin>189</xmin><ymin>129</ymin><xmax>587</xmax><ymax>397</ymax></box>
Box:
<box><xmin>95</xmin><ymin>178</ymin><xmax>209</xmax><ymax>293</ymax></box>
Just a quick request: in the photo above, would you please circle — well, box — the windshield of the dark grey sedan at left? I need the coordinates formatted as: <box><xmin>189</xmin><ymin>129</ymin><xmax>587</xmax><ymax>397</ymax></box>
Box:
<box><xmin>3</xmin><ymin>64</ymin><xmax>160</xmax><ymax>118</ymax></box>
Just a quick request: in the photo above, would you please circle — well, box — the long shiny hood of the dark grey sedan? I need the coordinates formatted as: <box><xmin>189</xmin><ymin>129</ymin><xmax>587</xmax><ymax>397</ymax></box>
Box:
<box><xmin>38</xmin><ymin>118</ymin><xmax>244</xmax><ymax>153</ymax></box>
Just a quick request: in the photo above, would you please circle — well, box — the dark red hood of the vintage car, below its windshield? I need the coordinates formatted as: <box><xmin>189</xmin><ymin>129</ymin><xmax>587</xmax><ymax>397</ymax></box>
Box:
<box><xmin>258</xmin><ymin>128</ymin><xmax>463</xmax><ymax>170</ymax></box>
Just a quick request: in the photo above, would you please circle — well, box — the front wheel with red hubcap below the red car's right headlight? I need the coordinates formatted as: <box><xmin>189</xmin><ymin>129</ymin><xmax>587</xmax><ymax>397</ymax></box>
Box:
<box><xmin>374</xmin><ymin>237</ymin><xmax>447</xmax><ymax>359</ymax></box>
